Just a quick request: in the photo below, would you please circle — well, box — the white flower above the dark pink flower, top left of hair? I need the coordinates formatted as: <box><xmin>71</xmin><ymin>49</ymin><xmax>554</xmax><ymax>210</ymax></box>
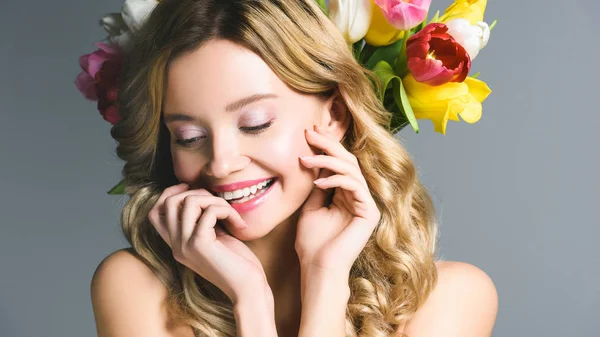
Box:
<box><xmin>100</xmin><ymin>0</ymin><xmax>158</xmax><ymax>50</ymax></box>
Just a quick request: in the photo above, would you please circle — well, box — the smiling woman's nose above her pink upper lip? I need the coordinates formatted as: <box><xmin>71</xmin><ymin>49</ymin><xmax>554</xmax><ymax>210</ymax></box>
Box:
<box><xmin>205</xmin><ymin>128</ymin><xmax>250</xmax><ymax>179</ymax></box>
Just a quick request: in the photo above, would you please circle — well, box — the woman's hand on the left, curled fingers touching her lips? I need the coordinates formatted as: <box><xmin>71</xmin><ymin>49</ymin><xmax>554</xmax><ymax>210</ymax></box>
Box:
<box><xmin>148</xmin><ymin>184</ymin><xmax>267</xmax><ymax>304</ymax></box>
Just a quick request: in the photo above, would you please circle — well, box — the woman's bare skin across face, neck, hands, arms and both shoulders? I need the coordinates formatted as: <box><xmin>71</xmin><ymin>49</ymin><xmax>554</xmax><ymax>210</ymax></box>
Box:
<box><xmin>92</xmin><ymin>41</ymin><xmax>497</xmax><ymax>337</ymax></box>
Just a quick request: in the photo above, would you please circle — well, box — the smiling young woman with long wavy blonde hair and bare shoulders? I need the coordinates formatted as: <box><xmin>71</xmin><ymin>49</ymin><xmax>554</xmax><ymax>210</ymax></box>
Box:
<box><xmin>91</xmin><ymin>0</ymin><xmax>497</xmax><ymax>337</ymax></box>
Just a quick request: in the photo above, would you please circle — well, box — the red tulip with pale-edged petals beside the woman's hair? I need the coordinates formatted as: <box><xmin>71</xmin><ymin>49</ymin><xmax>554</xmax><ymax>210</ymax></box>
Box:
<box><xmin>406</xmin><ymin>23</ymin><xmax>471</xmax><ymax>85</ymax></box>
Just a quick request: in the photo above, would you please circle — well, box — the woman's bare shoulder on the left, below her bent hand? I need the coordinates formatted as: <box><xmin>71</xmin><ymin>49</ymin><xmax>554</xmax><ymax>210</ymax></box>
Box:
<box><xmin>90</xmin><ymin>249</ymin><xmax>193</xmax><ymax>337</ymax></box>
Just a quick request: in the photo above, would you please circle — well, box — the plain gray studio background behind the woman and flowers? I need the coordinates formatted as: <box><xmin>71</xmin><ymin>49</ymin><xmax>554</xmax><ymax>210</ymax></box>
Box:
<box><xmin>0</xmin><ymin>0</ymin><xmax>600</xmax><ymax>337</ymax></box>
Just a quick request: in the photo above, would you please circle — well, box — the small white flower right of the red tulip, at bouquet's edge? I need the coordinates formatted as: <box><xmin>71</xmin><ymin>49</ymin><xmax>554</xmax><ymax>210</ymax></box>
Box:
<box><xmin>446</xmin><ymin>18</ymin><xmax>490</xmax><ymax>60</ymax></box>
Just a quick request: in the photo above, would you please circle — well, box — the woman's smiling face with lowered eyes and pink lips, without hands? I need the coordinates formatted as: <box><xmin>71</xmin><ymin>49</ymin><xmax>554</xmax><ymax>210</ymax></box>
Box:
<box><xmin>163</xmin><ymin>40</ymin><xmax>340</xmax><ymax>240</ymax></box>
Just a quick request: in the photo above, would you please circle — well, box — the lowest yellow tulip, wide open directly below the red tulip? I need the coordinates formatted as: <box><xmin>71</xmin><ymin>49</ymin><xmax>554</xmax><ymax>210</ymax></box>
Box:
<box><xmin>402</xmin><ymin>74</ymin><xmax>492</xmax><ymax>135</ymax></box>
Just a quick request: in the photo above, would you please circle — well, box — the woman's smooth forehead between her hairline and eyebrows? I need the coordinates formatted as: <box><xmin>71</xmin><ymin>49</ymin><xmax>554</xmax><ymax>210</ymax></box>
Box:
<box><xmin>165</xmin><ymin>40</ymin><xmax>291</xmax><ymax>112</ymax></box>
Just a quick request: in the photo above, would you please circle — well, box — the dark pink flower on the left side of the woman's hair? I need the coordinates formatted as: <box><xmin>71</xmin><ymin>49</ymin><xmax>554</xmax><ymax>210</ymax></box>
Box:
<box><xmin>75</xmin><ymin>42</ymin><xmax>123</xmax><ymax>124</ymax></box>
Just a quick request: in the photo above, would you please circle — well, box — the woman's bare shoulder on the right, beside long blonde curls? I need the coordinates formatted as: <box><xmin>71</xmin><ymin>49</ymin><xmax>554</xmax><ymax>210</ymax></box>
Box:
<box><xmin>403</xmin><ymin>261</ymin><xmax>498</xmax><ymax>337</ymax></box>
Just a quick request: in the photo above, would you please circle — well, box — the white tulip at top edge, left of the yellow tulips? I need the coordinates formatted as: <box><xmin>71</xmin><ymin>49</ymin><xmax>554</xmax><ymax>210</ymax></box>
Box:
<box><xmin>328</xmin><ymin>0</ymin><xmax>373</xmax><ymax>43</ymax></box>
